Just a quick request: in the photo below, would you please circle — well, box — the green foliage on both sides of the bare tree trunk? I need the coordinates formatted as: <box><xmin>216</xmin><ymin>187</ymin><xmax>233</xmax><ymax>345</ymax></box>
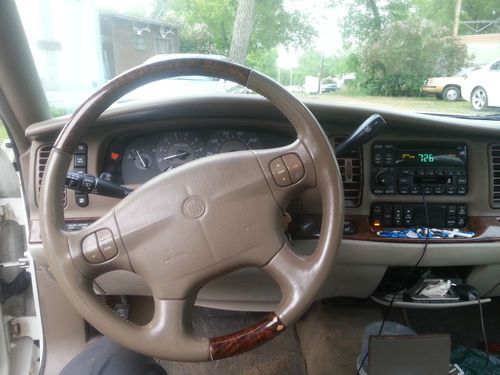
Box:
<box><xmin>162</xmin><ymin>0</ymin><xmax>315</xmax><ymax>77</ymax></box>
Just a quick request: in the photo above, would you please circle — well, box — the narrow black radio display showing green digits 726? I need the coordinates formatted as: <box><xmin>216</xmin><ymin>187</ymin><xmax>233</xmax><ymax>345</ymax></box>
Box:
<box><xmin>395</xmin><ymin>146</ymin><xmax>466</xmax><ymax>167</ymax></box>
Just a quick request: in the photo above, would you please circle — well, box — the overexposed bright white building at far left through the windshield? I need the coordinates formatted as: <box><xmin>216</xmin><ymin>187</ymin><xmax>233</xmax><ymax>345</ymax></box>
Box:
<box><xmin>16</xmin><ymin>0</ymin><xmax>105</xmax><ymax>108</ymax></box>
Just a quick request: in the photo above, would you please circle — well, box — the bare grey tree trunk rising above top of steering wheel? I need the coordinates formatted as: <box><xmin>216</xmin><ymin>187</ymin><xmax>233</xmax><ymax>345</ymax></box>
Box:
<box><xmin>229</xmin><ymin>0</ymin><xmax>256</xmax><ymax>64</ymax></box>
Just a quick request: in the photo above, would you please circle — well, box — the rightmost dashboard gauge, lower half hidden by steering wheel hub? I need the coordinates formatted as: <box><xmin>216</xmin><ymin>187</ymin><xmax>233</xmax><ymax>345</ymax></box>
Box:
<box><xmin>207</xmin><ymin>130</ymin><xmax>262</xmax><ymax>155</ymax></box>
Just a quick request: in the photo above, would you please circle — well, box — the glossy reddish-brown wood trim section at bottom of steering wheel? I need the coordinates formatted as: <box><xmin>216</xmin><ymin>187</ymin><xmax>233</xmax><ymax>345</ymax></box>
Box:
<box><xmin>210</xmin><ymin>313</ymin><xmax>285</xmax><ymax>360</ymax></box>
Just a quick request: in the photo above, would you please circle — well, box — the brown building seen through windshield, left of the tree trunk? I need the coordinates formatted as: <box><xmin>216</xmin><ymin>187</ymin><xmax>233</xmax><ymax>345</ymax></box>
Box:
<box><xmin>99</xmin><ymin>12</ymin><xmax>179</xmax><ymax>79</ymax></box>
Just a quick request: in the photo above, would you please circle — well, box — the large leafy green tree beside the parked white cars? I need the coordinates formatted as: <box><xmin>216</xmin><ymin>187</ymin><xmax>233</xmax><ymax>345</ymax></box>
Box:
<box><xmin>335</xmin><ymin>0</ymin><xmax>472</xmax><ymax>96</ymax></box>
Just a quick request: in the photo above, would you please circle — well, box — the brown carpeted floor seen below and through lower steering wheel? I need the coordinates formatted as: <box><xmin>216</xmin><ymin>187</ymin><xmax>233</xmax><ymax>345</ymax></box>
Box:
<box><xmin>160</xmin><ymin>308</ymin><xmax>307</xmax><ymax>375</ymax></box>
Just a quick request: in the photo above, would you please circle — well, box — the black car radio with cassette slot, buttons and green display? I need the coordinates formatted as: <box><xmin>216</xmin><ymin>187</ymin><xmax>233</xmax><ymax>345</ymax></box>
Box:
<box><xmin>371</xmin><ymin>143</ymin><xmax>467</xmax><ymax>195</ymax></box>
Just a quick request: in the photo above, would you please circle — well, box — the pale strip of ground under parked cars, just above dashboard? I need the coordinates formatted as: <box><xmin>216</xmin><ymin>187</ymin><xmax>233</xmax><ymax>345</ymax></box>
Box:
<box><xmin>298</xmin><ymin>91</ymin><xmax>500</xmax><ymax>115</ymax></box>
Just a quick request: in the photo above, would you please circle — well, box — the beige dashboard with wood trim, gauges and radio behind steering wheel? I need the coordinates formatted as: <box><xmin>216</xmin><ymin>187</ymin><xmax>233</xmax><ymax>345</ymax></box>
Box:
<box><xmin>21</xmin><ymin>96</ymin><xmax>500</xmax><ymax>310</ymax></box>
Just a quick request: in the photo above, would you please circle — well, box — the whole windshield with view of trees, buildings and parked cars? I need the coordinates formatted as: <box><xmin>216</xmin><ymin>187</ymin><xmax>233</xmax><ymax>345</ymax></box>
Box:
<box><xmin>17</xmin><ymin>0</ymin><xmax>500</xmax><ymax>116</ymax></box>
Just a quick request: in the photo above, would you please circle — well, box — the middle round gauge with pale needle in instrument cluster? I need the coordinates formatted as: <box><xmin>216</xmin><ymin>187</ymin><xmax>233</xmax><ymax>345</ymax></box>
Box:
<box><xmin>156</xmin><ymin>131</ymin><xmax>205</xmax><ymax>172</ymax></box>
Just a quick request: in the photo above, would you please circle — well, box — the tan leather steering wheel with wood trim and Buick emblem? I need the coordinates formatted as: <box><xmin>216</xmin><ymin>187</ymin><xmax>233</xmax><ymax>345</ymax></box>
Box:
<box><xmin>40</xmin><ymin>57</ymin><xmax>343</xmax><ymax>361</ymax></box>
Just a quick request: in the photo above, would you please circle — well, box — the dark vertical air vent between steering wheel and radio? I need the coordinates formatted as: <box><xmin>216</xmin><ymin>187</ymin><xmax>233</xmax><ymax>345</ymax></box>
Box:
<box><xmin>330</xmin><ymin>136</ymin><xmax>363</xmax><ymax>207</ymax></box>
